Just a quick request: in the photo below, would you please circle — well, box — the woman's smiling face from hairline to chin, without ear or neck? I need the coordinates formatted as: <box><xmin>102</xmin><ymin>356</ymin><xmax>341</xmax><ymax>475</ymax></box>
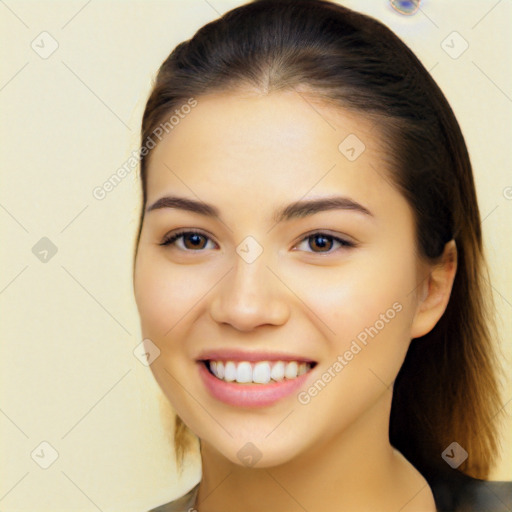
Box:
<box><xmin>134</xmin><ymin>92</ymin><xmax>426</xmax><ymax>467</ymax></box>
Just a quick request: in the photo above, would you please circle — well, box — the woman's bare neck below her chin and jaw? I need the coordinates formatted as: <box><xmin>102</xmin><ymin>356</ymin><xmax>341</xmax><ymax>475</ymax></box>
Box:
<box><xmin>196</xmin><ymin>392</ymin><xmax>435</xmax><ymax>512</ymax></box>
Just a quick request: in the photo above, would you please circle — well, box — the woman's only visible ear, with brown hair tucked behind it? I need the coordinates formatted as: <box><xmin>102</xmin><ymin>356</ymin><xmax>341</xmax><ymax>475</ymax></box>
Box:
<box><xmin>411</xmin><ymin>240</ymin><xmax>457</xmax><ymax>338</ymax></box>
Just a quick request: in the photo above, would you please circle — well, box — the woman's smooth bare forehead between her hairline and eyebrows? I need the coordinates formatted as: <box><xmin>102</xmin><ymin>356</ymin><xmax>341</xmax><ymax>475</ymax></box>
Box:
<box><xmin>147</xmin><ymin>91</ymin><xmax>404</xmax><ymax>219</ymax></box>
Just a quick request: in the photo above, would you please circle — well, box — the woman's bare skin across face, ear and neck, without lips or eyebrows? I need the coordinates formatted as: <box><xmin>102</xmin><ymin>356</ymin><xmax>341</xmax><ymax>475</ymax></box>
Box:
<box><xmin>134</xmin><ymin>91</ymin><xmax>456</xmax><ymax>512</ymax></box>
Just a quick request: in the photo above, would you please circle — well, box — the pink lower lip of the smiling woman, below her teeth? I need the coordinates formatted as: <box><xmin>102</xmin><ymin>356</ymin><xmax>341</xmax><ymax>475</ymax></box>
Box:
<box><xmin>198</xmin><ymin>362</ymin><xmax>312</xmax><ymax>407</ymax></box>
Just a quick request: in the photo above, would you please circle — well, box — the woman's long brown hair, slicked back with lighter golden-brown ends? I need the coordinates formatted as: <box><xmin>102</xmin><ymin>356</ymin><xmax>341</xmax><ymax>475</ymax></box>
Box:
<box><xmin>135</xmin><ymin>0</ymin><xmax>501</xmax><ymax>478</ymax></box>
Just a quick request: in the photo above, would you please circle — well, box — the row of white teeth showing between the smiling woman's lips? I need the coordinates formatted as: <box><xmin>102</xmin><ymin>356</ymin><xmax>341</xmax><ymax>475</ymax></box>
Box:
<box><xmin>199</xmin><ymin>359</ymin><xmax>317</xmax><ymax>384</ymax></box>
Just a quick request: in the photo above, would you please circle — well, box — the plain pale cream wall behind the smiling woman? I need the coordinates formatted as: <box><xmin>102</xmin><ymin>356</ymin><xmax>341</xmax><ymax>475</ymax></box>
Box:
<box><xmin>0</xmin><ymin>0</ymin><xmax>512</xmax><ymax>512</ymax></box>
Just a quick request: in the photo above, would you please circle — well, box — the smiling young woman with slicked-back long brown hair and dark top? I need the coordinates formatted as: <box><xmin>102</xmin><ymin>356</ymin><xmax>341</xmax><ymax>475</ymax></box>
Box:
<box><xmin>134</xmin><ymin>0</ymin><xmax>511</xmax><ymax>512</ymax></box>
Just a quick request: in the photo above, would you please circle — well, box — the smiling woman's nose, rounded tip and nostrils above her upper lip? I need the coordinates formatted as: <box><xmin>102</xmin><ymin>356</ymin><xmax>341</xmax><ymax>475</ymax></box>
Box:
<box><xmin>210</xmin><ymin>257</ymin><xmax>289</xmax><ymax>331</ymax></box>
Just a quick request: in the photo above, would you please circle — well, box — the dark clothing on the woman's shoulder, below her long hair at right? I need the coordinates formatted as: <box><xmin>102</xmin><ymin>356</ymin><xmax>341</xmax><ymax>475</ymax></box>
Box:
<box><xmin>425</xmin><ymin>466</ymin><xmax>512</xmax><ymax>512</ymax></box>
